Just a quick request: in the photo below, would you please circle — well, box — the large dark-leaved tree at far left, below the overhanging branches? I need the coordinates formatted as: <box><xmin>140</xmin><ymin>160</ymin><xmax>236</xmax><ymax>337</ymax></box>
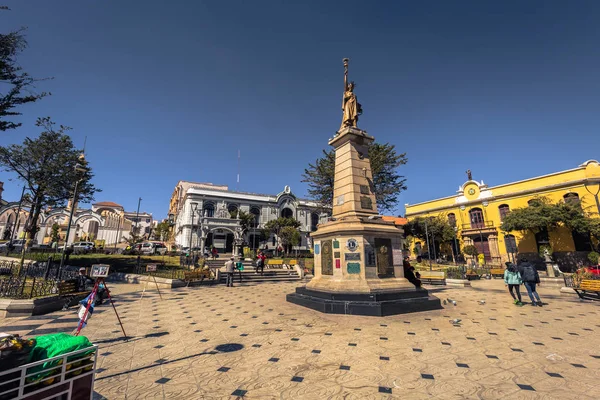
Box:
<box><xmin>0</xmin><ymin>117</ymin><xmax>100</xmax><ymax>238</ymax></box>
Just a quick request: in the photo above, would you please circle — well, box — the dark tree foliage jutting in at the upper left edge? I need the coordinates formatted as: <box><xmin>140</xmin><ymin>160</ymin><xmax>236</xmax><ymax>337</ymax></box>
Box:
<box><xmin>0</xmin><ymin>17</ymin><xmax>50</xmax><ymax>131</ymax></box>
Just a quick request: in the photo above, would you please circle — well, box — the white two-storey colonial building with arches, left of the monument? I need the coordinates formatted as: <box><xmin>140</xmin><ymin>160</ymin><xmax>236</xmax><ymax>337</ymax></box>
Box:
<box><xmin>169</xmin><ymin>181</ymin><xmax>330</xmax><ymax>254</ymax></box>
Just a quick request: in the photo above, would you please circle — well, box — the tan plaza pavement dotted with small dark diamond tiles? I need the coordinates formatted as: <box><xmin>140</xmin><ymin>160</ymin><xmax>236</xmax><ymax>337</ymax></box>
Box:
<box><xmin>0</xmin><ymin>280</ymin><xmax>600</xmax><ymax>400</ymax></box>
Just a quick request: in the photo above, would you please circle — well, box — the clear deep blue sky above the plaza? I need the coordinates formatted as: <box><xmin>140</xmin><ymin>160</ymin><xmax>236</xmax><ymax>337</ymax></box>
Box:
<box><xmin>0</xmin><ymin>0</ymin><xmax>600</xmax><ymax>217</ymax></box>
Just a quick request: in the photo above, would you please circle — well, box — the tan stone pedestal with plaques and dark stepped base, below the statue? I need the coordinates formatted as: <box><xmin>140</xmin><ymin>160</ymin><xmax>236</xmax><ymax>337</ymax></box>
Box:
<box><xmin>287</xmin><ymin>127</ymin><xmax>442</xmax><ymax>316</ymax></box>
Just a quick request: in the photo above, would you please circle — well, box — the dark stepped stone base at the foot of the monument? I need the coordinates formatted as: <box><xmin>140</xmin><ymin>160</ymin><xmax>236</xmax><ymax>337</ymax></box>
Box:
<box><xmin>286</xmin><ymin>287</ymin><xmax>443</xmax><ymax>317</ymax></box>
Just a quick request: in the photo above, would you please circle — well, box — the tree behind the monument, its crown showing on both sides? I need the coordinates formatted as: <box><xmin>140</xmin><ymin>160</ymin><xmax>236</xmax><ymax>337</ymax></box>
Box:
<box><xmin>302</xmin><ymin>143</ymin><xmax>408</xmax><ymax>212</ymax></box>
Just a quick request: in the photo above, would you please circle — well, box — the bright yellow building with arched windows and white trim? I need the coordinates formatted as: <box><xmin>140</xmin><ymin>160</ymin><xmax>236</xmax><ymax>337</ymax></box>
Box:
<box><xmin>406</xmin><ymin>160</ymin><xmax>600</xmax><ymax>266</ymax></box>
